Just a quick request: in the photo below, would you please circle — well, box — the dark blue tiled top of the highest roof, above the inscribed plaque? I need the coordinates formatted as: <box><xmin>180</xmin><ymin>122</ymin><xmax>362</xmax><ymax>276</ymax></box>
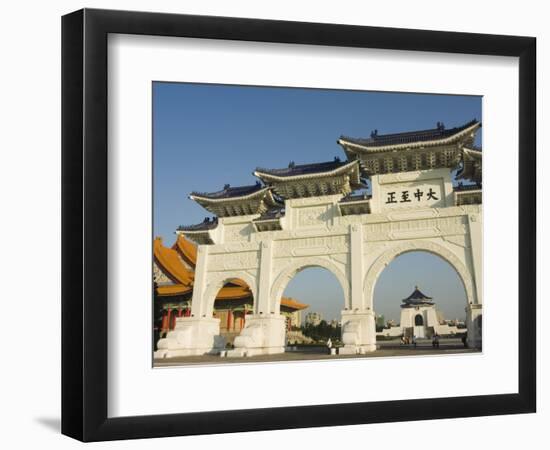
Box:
<box><xmin>340</xmin><ymin>119</ymin><xmax>478</xmax><ymax>147</ymax></box>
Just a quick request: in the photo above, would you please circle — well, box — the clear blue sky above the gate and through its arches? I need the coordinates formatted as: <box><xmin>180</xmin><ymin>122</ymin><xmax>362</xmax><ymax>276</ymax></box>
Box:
<box><xmin>153</xmin><ymin>82</ymin><xmax>481</xmax><ymax>319</ymax></box>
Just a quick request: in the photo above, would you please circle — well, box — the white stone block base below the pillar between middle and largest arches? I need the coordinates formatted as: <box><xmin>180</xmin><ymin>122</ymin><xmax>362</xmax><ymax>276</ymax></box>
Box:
<box><xmin>338</xmin><ymin>310</ymin><xmax>376</xmax><ymax>355</ymax></box>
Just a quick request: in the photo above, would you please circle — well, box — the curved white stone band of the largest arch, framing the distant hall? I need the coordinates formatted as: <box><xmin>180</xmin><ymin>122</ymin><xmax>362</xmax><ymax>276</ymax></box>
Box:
<box><xmin>363</xmin><ymin>240</ymin><xmax>477</xmax><ymax>304</ymax></box>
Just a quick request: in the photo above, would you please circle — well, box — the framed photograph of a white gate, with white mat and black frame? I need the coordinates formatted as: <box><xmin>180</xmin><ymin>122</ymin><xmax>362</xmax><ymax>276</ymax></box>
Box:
<box><xmin>62</xmin><ymin>9</ymin><xmax>536</xmax><ymax>441</ymax></box>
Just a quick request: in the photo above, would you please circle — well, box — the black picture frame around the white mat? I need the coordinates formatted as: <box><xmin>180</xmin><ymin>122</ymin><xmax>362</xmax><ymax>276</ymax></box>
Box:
<box><xmin>62</xmin><ymin>9</ymin><xmax>536</xmax><ymax>441</ymax></box>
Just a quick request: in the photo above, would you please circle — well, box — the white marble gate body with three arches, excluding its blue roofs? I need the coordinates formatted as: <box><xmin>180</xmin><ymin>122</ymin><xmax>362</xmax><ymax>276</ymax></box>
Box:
<box><xmin>159</xmin><ymin>169</ymin><xmax>483</xmax><ymax>357</ymax></box>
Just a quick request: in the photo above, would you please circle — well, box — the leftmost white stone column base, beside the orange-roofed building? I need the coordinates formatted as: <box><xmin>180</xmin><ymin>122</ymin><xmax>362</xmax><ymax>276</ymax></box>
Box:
<box><xmin>154</xmin><ymin>317</ymin><xmax>225</xmax><ymax>358</ymax></box>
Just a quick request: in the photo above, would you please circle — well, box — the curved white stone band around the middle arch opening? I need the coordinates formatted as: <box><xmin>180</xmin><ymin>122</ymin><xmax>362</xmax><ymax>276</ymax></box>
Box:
<box><xmin>269</xmin><ymin>257</ymin><xmax>351</xmax><ymax>312</ymax></box>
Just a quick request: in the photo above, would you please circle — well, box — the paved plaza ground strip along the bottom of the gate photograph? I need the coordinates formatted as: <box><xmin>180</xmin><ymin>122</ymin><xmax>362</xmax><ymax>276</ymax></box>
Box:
<box><xmin>154</xmin><ymin>338</ymin><xmax>480</xmax><ymax>367</ymax></box>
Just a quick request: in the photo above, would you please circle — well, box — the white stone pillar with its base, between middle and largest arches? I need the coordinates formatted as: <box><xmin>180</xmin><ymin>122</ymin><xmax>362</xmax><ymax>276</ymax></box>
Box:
<box><xmin>339</xmin><ymin>224</ymin><xmax>376</xmax><ymax>355</ymax></box>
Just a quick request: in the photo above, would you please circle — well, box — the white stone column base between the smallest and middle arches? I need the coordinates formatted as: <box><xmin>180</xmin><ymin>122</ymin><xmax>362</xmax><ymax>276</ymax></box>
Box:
<box><xmin>227</xmin><ymin>314</ymin><xmax>286</xmax><ymax>357</ymax></box>
